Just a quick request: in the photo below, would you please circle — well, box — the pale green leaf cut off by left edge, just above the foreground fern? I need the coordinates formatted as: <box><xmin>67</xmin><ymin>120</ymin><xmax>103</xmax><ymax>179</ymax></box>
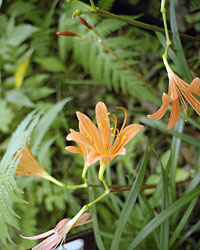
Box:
<box><xmin>0</xmin><ymin>99</ymin><xmax>14</xmax><ymax>133</ymax></box>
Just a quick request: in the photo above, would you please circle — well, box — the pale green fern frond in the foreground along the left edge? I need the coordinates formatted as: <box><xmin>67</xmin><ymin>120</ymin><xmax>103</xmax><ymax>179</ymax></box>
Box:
<box><xmin>0</xmin><ymin>112</ymin><xmax>38</xmax><ymax>244</ymax></box>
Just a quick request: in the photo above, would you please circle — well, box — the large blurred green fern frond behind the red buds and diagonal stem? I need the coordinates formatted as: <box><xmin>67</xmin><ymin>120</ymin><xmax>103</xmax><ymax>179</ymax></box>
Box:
<box><xmin>60</xmin><ymin>13</ymin><xmax>157</xmax><ymax>103</ymax></box>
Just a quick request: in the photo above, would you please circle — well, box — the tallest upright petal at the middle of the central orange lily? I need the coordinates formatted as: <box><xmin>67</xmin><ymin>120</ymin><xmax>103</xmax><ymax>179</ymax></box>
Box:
<box><xmin>95</xmin><ymin>102</ymin><xmax>111</xmax><ymax>152</ymax></box>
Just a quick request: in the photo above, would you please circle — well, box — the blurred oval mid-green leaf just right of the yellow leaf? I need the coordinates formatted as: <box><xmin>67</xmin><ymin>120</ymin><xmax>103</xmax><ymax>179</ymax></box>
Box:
<box><xmin>35</xmin><ymin>57</ymin><xmax>66</xmax><ymax>72</ymax></box>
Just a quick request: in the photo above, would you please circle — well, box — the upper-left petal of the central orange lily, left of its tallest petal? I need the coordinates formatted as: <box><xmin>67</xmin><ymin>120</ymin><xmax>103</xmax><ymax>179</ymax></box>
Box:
<box><xmin>76</xmin><ymin>112</ymin><xmax>102</xmax><ymax>152</ymax></box>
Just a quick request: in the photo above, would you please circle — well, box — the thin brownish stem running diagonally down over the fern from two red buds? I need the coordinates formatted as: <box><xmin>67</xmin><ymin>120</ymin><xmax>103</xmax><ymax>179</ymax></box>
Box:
<box><xmin>99</xmin><ymin>41</ymin><xmax>160</xmax><ymax>98</ymax></box>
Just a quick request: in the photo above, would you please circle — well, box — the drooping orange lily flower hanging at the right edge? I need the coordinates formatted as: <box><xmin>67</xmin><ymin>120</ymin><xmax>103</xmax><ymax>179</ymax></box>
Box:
<box><xmin>147</xmin><ymin>64</ymin><xmax>200</xmax><ymax>129</ymax></box>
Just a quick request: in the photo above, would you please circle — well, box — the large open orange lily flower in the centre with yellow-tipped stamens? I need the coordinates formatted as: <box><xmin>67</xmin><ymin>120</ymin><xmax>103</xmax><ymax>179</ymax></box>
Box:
<box><xmin>67</xmin><ymin>102</ymin><xmax>143</xmax><ymax>167</ymax></box>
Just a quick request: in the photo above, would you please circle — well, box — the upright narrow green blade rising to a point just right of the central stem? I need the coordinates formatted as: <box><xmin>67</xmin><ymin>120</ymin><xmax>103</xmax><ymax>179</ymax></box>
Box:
<box><xmin>110</xmin><ymin>147</ymin><xmax>148</xmax><ymax>250</ymax></box>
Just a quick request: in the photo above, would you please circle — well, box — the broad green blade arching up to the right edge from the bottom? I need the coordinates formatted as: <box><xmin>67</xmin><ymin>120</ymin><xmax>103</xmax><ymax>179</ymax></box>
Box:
<box><xmin>127</xmin><ymin>187</ymin><xmax>200</xmax><ymax>250</ymax></box>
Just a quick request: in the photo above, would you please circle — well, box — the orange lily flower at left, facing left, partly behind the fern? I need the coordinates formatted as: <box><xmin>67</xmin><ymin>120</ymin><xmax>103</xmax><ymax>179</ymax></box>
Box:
<box><xmin>15</xmin><ymin>137</ymin><xmax>50</xmax><ymax>179</ymax></box>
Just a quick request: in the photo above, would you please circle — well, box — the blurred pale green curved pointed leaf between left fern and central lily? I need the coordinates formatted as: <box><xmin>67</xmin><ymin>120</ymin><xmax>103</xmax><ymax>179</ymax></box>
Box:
<box><xmin>32</xmin><ymin>97</ymin><xmax>72</xmax><ymax>155</ymax></box>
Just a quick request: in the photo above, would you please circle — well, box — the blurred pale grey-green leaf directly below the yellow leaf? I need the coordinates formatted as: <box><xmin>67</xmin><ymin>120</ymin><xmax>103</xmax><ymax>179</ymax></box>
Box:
<box><xmin>6</xmin><ymin>89</ymin><xmax>35</xmax><ymax>108</ymax></box>
